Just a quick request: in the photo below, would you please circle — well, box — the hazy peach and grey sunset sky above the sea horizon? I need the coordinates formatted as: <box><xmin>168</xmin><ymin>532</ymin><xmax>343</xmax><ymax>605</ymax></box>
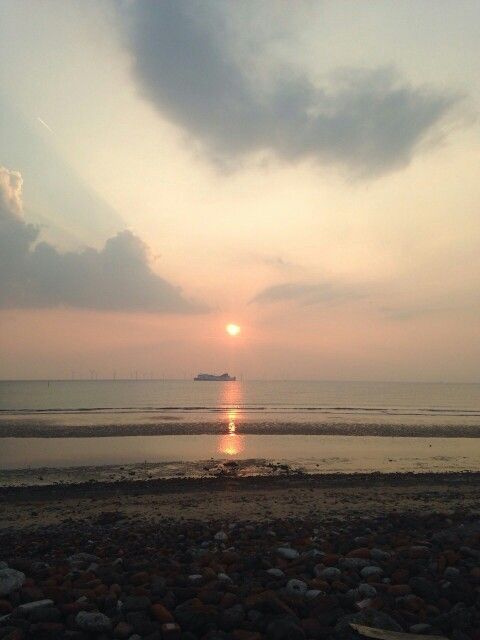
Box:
<box><xmin>0</xmin><ymin>0</ymin><xmax>480</xmax><ymax>382</ymax></box>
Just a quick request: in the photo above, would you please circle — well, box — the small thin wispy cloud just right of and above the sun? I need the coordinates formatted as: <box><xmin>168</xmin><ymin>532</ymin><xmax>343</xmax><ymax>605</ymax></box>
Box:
<box><xmin>251</xmin><ymin>282</ymin><xmax>366</xmax><ymax>305</ymax></box>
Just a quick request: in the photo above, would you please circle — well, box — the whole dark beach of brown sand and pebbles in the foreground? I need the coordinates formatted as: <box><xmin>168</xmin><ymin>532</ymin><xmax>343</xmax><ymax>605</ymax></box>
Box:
<box><xmin>0</xmin><ymin>473</ymin><xmax>480</xmax><ymax>640</ymax></box>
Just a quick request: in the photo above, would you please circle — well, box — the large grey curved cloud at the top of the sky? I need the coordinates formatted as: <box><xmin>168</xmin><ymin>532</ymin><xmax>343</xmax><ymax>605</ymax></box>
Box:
<box><xmin>128</xmin><ymin>0</ymin><xmax>458</xmax><ymax>176</ymax></box>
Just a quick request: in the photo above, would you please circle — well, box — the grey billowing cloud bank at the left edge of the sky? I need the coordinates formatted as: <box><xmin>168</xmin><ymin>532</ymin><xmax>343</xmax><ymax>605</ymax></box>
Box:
<box><xmin>0</xmin><ymin>167</ymin><xmax>205</xmax><ymax>313</ymax></box>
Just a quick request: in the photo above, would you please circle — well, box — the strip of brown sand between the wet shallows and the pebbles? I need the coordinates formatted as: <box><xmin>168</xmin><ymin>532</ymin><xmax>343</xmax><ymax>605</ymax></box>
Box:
<box><xmin>0</xmin><ymin>472</ymin><xmax>480</xmax><ymax>530</ymax></box>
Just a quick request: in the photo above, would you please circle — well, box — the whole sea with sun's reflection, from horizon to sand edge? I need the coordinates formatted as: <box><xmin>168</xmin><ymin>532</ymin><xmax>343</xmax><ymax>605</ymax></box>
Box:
<box><xmin>0</xmin><ymin>380</ymin><xmax>480</xmax><ymax>485</ymax></box>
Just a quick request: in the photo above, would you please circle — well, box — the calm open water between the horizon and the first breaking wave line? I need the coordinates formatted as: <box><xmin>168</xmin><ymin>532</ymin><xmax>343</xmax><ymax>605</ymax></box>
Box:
<box><xmin>0</xmin><ymin>380</ymin><xmax>480</xmax><ymax>421</ymax></box>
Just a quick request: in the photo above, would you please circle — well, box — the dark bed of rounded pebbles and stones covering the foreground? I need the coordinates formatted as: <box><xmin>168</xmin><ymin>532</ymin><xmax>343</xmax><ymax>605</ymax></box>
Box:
<box><xmin>0</xmin><ymin>513</ymin><xmax>480</xmax><ymax>640</ymax></box>
